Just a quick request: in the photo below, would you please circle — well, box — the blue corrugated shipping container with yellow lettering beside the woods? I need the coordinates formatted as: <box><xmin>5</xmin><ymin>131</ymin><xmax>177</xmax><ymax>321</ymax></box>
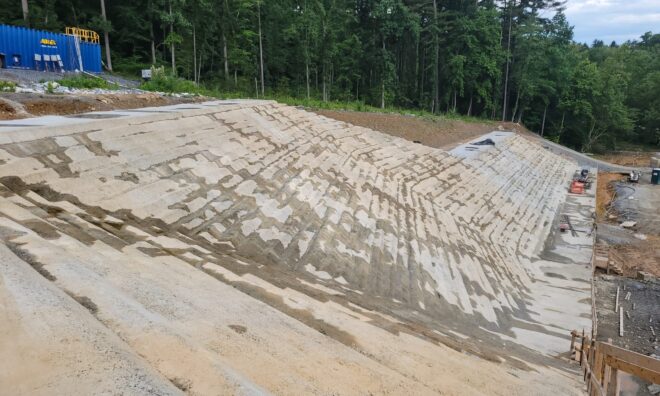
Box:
<box><xmin>0</xmin><ymin>25</ymin><xmax>101</xmax><ymax>73</ymax></box>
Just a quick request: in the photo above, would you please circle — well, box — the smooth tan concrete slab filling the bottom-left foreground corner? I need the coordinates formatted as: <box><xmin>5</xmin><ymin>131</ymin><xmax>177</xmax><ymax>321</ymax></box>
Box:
<box><xmin>0</xmin><ymin>244</ymin><xmax>181</xmax><ymax>395</ymax></box>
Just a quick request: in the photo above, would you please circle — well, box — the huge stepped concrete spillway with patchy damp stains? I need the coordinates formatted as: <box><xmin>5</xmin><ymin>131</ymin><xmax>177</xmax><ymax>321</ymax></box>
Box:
<box><xmin>0</xmin><ymin>101</ymin><xmax>593</xmax><ymax>394</ymax></box>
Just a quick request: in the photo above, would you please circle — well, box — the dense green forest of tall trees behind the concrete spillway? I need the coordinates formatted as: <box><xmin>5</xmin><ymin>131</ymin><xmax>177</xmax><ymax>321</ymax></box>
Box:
<box><xmin>0</xmin><ymin>0</ymin><xmax>660</xmax><ymax>152</ymax></box>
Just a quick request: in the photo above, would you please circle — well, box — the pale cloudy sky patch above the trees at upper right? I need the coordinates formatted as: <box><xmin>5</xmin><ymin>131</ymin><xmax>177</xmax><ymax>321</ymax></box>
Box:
<box><xmin>565</xmin><ymin>0</ymin><xmax>660</xmax><ymax>44</ymax></box>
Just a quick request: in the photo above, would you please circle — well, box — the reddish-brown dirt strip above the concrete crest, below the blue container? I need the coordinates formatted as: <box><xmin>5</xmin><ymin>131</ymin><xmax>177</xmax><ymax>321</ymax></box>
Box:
<box><xmin>0</xmin><ymin>93</ymin><xmax>208</xmax><ymax>120</ymax></box>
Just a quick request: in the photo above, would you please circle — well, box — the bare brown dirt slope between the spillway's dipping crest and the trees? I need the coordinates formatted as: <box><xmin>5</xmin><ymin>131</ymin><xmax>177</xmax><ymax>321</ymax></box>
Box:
<box><xmin>315</xmin><ymin>110</ymin><xmax>528</xmax><ymax>148</ymax></box>
